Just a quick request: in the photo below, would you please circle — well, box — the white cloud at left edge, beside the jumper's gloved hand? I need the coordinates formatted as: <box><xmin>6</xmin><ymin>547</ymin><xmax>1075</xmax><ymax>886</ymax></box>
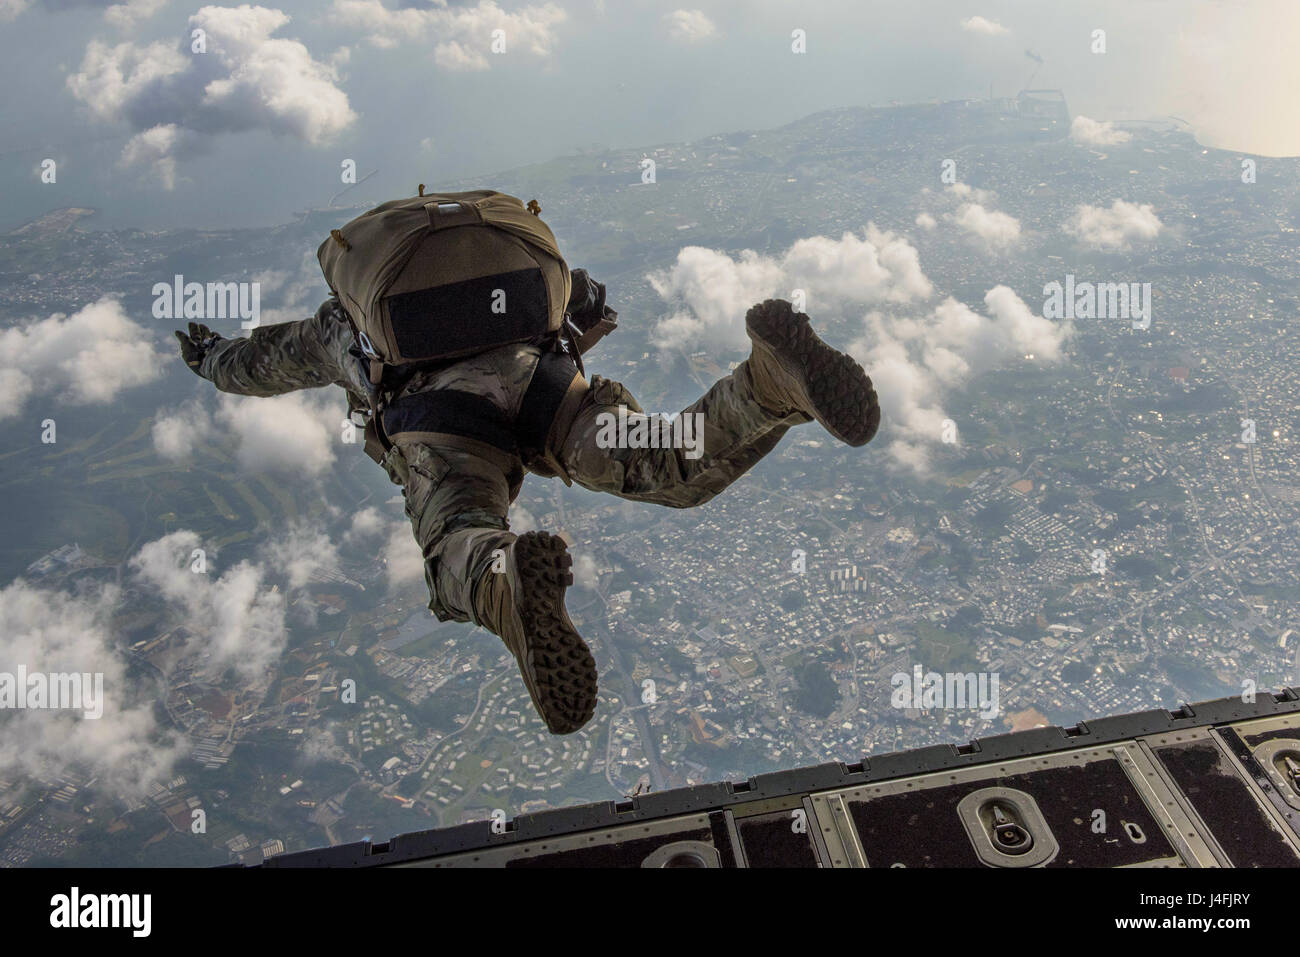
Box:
<box><xmin>0</xmin><ymin>296</ymin><xmax>169</xmax><ymax>419</ymax></box>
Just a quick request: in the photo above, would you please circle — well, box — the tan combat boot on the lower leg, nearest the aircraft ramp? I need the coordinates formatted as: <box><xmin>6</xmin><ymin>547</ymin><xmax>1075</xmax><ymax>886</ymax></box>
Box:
<box><xmin>475</xmin><ymin>532</ymin><xmax>597</xmax><ymax>735</ymax></box>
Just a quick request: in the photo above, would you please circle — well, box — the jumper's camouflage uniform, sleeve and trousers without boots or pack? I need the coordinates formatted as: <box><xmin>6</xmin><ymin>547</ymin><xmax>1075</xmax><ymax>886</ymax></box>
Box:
<box><xmin>198</xmin><ymin>300</ymin><xmax>810</xmax><ymax>635</ymax></box>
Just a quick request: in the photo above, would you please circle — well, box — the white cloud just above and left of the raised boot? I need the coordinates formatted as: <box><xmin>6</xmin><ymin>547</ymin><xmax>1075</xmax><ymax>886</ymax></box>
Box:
<box><xmin>647</xmin><ymin>224</ymin><xmax>933</xmax><ymax>350</ymax></box>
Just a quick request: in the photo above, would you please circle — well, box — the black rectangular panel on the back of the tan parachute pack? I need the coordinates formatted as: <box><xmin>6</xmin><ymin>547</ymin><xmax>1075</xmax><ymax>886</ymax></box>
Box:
<box><xmin>386</xmin><ymin>267</ymin><xmax>550</xmax><ymax>360</ymax></box>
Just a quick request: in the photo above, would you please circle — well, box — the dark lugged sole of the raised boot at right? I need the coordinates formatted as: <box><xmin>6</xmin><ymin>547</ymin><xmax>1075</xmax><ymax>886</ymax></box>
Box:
<box><xmin>745</xmin><ymin>299</ymin><xmax>880</xmax><ymax>446</ymax></box>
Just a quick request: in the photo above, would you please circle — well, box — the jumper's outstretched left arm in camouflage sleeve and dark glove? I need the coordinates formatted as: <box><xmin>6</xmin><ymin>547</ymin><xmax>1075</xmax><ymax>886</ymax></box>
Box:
<box><xmin>177</xmin><ymin>299</ymin><xmax>358</xmax><ymax>395</ymax></box>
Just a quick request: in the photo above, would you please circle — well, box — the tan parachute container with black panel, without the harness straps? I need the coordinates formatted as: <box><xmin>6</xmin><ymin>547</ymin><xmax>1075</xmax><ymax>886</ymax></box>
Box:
<box><xmin>316</xmin><ymin>186</ymin><xmax>569</xmax><ymax>365</ymax></box>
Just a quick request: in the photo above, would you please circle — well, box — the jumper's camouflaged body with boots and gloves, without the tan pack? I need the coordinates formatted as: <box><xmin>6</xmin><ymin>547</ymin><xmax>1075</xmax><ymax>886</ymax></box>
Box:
<box><xmin>176</xmin><ymin>187</ymin><xmax>880</xmax><ymax>735</ymax></box>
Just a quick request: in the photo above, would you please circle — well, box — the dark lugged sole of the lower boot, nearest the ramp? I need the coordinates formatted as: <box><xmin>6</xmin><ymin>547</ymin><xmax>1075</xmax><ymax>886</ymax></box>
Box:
<box><xmin>515</xmin><ymin>532</ymin><xmax>597</xmax><ymax>735</ymax></box>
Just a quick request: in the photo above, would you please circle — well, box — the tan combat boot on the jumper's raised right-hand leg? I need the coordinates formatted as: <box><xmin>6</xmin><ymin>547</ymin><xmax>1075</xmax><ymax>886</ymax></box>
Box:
<box><xmin>745</xmin><ymin>299</ymin><xmax>880</xmax><ymax>446</ymax></box>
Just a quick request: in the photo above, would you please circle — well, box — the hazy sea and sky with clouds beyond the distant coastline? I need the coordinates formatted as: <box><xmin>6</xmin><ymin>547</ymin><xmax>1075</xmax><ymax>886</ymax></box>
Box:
<box><xmin>0</xmin><ymin>0</ymin><xmax>1300</xmax><ymax>230</ymax></box>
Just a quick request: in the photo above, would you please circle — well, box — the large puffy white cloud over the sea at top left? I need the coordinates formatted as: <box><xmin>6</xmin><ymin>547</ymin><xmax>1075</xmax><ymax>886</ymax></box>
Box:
<box><xmin>68</xmin><ymin>4</ymin><xmax>356</xmax><ymax>189</ymax></box>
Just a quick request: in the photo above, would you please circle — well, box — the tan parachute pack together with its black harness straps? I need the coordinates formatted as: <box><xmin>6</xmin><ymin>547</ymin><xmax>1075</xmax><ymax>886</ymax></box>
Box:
<box><xmin>316</xmin><ymin>185</ymin><xmax>618</xmax><ymax>462</ymax></box>
